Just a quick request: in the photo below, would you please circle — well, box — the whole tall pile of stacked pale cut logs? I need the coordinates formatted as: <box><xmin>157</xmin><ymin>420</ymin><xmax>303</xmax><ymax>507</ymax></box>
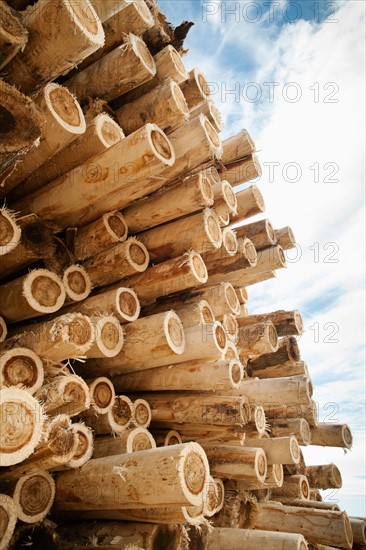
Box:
<box><xmin>0</xmin><ymin>0</ymin><xmax>366</xmax><ymax>550</ymax></box>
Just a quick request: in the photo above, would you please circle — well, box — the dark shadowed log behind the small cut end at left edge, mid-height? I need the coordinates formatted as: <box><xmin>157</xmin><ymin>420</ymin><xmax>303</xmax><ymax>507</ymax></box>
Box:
<box><xmin>0</xmin><ymin>216</ymin><xmax>55</xmax><ymax>279</ymax></box>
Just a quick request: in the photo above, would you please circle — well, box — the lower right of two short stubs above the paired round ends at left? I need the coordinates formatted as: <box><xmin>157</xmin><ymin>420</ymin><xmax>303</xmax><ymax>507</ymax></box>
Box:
<box><xmin>84</xmin><ymin>237</ymin><xmax>150</xmax><ymax>287</ymax></box>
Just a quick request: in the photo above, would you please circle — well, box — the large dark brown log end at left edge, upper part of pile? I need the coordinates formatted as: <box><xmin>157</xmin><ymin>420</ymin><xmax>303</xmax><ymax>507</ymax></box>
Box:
<box><xmin>0</xmin><ymin>80</ymin><xmax>44</xmax><ymax>180</ymax></box>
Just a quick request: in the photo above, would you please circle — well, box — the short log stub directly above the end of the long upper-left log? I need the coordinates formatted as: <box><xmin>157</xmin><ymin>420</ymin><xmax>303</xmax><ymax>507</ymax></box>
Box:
<box><xmin>116</xmin><ymin>78</ymin><xmax>189</xmax><ymax>135</ymax></box>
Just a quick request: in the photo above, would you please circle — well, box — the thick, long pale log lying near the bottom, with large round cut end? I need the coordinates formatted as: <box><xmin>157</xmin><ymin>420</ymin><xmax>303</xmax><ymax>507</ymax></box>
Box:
<box><xmin>56</xmin><ymin>443</ymin><xmax>209</xmax><ymax>511</ymax></box>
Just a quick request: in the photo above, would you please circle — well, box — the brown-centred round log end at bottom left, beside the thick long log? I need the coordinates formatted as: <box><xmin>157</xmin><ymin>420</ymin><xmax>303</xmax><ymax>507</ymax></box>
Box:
<box><xmin>4</xmin><ymin>470</ymin><xmax>55</xmax><ymax>523</ymax></box>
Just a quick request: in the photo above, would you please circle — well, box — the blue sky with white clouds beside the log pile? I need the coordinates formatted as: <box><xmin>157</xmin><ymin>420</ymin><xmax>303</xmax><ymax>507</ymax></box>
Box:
<box><xmin>159</xmin><ymin>0</ymin><xmax>366</xmax><ymax>516</ymax></box>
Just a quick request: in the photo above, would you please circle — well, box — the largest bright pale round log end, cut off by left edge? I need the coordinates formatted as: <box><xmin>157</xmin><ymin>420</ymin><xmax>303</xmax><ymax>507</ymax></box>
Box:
<box><xmin>0</xmin><ymin>387</ymin><xmax>44</xmax><ymax>466</ymax></box>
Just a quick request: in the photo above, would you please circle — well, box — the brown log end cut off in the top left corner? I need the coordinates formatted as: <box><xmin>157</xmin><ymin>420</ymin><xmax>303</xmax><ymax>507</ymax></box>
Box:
<box><xmin>0</xmin><ymin>2</ymin><xmax>28</xmax><ymax>71</ymax></box>
